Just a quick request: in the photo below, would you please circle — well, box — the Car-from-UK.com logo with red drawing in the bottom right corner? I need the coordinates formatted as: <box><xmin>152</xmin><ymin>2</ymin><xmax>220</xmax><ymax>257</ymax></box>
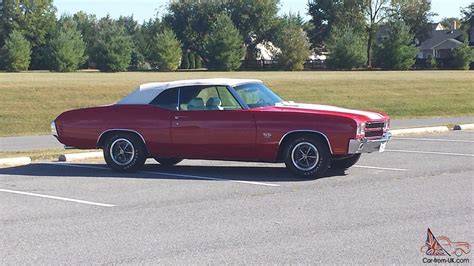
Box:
<box><xmin>420</xmin><ymin>228</ymin><xmax>471</xmax><ymax>263</ymax></box>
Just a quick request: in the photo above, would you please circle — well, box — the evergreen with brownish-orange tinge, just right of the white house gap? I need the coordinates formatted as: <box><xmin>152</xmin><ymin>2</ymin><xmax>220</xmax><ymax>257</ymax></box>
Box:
<box><xmin>275</xmin><ymin>14</ymin><xmax>311</xmax><ymax>71</ymax></box>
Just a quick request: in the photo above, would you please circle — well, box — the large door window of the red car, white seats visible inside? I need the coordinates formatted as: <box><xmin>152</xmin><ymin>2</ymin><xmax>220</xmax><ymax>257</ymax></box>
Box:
<box><xmin>179</xmin><ymin>86</ymin><xmax>242</xmax><ymax>111</ymax></box>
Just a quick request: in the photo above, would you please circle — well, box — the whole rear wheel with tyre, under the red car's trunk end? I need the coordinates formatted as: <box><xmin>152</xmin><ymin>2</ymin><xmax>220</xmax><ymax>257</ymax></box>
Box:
<box><xmin>104</xmin><ymin>133</ymin><xmax>147</xmax><ymax>172</ymax></box>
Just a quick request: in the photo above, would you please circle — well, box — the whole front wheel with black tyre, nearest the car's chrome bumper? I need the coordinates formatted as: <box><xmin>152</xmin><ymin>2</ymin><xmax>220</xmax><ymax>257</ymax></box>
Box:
<box><xmin>285</xmin><ymin>137</ymin><xmax>331</xmax><ymax>179</ymax></box>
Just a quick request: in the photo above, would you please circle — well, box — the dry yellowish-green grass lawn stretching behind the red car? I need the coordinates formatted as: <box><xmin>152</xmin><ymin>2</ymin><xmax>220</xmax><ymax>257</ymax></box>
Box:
<box><xmin>0</xmin><ymin>71</ymin><xmax>474</xmax><ymax>136</ymax></box>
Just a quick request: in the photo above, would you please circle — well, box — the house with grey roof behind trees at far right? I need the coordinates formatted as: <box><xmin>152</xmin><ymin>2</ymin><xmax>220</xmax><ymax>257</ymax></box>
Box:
<box><xmin>417</xmin><ymin>22</ymin><xmax>465</xmax><ymax>59</ymax></box>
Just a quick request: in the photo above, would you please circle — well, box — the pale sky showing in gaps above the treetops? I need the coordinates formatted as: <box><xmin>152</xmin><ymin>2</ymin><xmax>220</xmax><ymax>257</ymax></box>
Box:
<box><xmin>54</xmin><ymin>0</ymin><xmax>472</xmax><ymax>21</ymax></box>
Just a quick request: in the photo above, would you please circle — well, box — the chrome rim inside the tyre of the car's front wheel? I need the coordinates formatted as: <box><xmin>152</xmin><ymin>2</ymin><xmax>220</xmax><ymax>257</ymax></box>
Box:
<box><xmin>291</xmin><ymin>142</ymin><xmax>319</xmax><ymax>171</ymax></box>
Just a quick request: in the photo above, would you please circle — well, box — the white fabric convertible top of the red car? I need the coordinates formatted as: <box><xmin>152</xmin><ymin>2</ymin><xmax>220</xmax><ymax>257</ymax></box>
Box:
<box><xmin>116</xmin><ymin>78</ymin><xmax>263</xmax><ymax>104</ymax></box>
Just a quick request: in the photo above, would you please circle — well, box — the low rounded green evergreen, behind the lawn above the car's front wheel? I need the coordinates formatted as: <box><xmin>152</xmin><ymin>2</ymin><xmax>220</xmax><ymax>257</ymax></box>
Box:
<box><xmin>327</xmin><ymin>28</ymin><xmax>367</xmax><ymax>69</ymax></box>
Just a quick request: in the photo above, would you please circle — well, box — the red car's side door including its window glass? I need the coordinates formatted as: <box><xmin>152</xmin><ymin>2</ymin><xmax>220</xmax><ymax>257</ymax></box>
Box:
<box><xmin>171</xmin><ymin>86</ymin><xmax>256</xmax><ymax>160</ymax></box>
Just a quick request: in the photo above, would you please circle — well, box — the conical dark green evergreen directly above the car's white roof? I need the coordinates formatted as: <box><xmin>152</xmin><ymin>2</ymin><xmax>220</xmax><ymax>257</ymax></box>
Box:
<box><xmin>206</xmin><ymin>13</ymin><xmax>245</xmax><ymax>71</ymax></box>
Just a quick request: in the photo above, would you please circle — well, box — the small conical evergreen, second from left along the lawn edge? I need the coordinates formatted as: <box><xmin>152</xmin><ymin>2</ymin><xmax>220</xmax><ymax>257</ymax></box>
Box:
<box><xmin>49</xmin><ymin>17</ymin><xmax>87</xmax><ymax>72</ymax></box>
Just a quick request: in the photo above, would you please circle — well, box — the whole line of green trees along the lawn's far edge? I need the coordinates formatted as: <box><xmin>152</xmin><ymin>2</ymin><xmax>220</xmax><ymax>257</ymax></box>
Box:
<box><xmin>0</xmin><ymin>0</ymin><xmax>474</xmax><ymax>72</ymax></box>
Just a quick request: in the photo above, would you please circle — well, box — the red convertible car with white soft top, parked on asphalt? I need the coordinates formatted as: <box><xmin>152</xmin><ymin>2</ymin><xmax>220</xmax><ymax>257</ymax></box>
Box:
<box><xmin>51</xmin><ymin>79</ymin><xmax>391</xmax><ymax>178</ymax></box>
